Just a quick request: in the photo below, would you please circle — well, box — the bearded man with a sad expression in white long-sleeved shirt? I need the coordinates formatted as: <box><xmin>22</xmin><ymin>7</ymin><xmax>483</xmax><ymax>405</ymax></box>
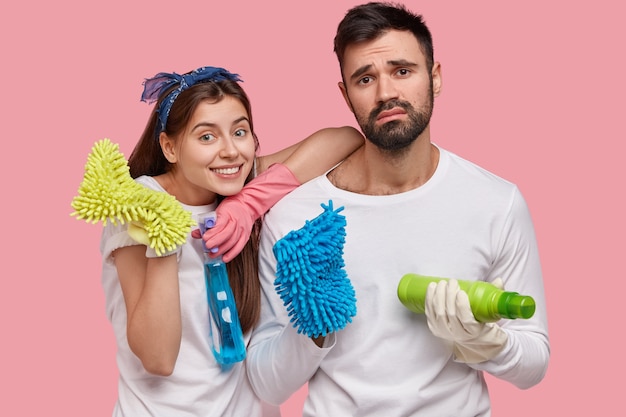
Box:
<box><xmin>247</xmin><ymin>3</ymin><xmax>549</xmax><ymax>417</ymax></box>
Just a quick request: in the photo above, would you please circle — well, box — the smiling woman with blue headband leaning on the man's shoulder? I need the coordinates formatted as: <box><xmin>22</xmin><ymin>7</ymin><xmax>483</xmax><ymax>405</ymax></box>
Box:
<box><xmin>101</xmin><ymin>67</ymin><xmax>363</xmax><ymax>417</ymax></box>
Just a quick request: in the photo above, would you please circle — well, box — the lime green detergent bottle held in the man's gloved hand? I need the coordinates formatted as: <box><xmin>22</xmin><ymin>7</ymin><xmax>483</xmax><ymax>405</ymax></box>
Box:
<box><xmin>398</xmin><ymin>274</ymin><xmax>535</xmax><ymax>323</ymax></box>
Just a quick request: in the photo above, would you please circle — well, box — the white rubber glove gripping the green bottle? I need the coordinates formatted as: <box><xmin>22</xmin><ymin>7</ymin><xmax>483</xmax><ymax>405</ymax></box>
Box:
<box><xmin>424</xmin><ymin>279</ymin><xmax>507</xmax><ymax>363</ymax></box>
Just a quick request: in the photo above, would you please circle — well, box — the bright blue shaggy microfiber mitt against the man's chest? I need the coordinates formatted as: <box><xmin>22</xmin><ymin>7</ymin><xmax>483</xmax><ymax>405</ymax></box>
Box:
<box><xmin>273</xmin><ymin>200</ymin><xmax>356</xmax><ymax>337</ymax></box>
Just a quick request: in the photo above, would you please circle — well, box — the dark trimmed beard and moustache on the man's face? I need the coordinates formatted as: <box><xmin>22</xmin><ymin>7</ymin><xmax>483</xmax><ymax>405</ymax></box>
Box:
<box><xmin>357</xmin><ymin>88</ymin><xmax>434</xmax><ymax>152</ymax></box>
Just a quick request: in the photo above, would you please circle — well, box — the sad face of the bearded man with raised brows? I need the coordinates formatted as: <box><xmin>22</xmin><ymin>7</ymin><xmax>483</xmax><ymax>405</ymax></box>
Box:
<box><xmin>339</xmin><ymin>31</ymin><xmax>441</xmax><ymax>151</ymax></box>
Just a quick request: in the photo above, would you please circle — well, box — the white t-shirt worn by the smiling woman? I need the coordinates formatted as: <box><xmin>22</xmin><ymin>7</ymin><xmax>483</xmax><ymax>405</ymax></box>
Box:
<box><xmin>101</xmin><ymin>176</ymin><xmax>280</xmax><ymax>417</ymax></box>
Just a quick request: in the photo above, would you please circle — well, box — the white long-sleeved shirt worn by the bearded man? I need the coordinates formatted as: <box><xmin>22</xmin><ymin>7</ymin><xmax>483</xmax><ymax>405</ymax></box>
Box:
<box><xmin>247</xmin><ymin>149</ymin><xmax>549</xmax><ymax>417</ymax></box>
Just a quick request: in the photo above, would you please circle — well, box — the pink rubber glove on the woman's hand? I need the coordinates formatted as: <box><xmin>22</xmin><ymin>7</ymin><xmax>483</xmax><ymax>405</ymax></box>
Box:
<box><xmin>192</xmin><ymin>163</ymin><xmax>300</xmax><ymax>262</ymax></box>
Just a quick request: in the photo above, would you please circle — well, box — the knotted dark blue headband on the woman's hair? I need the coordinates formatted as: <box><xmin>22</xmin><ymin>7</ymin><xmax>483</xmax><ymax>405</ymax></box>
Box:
<box><xmin>141</xmin><ymin>67</ymin><xmax>242</xmax><ymax>136</ymax></box>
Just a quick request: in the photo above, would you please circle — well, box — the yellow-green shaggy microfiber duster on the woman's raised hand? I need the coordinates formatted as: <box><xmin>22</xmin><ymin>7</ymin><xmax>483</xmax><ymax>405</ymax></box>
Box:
<box><xmin>71</xmin><ymin>139</ymin><xmax>195</xmax><ymax>255</ymax></box>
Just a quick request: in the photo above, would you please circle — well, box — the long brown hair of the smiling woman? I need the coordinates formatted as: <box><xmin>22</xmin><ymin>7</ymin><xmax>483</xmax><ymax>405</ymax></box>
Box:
<box><xmin>128</xmin><ymin>80</ymin><xmax>261</xmax><ymax>333</ymax></box>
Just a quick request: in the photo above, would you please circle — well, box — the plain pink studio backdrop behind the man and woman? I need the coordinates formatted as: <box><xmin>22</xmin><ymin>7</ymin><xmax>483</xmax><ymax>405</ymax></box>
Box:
<box><xmin>0</xmin><ymin>0</ymin><xmax>626</xmax><ymax>417</ymax></box>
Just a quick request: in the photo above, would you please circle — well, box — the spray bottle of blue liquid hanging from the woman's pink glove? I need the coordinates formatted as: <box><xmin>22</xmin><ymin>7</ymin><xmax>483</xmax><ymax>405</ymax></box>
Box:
<box><xmin>199</xmin><ymin>212</ymin><xmax>246</xmax><ymax>365</ymax></box>
